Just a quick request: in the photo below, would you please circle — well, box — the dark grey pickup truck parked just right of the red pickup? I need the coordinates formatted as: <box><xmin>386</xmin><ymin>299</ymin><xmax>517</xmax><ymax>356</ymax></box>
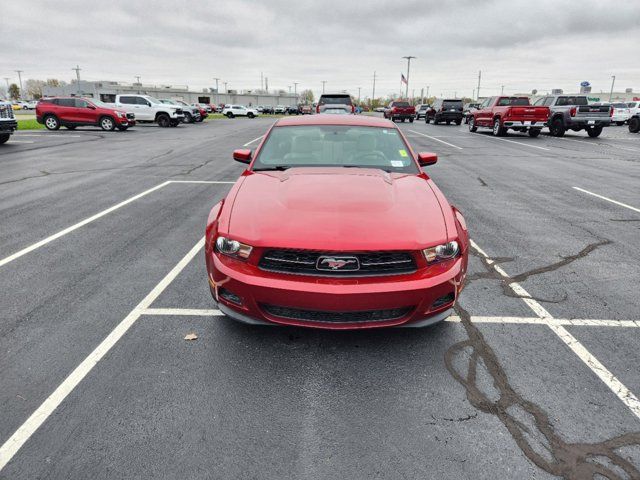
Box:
<box><xmin>534</xmin><ymin>95</ymin><xmax>613</xmax><ymax>138</ymax></box>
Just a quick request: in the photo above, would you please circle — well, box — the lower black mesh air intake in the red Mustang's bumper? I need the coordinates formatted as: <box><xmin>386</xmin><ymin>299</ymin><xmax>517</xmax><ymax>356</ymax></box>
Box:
<box><xmin>260</xmin><ymin>304</ymin><xmax>414</xmax><ymax>323</ymax></box>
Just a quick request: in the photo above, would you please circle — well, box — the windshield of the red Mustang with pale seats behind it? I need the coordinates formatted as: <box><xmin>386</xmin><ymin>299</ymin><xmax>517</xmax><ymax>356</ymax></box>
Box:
<box><xmin>253</xmin><ymin>125</ymin><xmax>418</xmax><ymax>173</ymax></box>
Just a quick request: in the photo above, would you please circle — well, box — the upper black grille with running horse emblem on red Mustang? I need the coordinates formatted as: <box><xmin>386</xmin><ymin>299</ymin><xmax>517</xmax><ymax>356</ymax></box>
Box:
<box><xmin>259</xmin><ymin>250</ymin><xmax>416</xmax><ymax>277</ymax></box>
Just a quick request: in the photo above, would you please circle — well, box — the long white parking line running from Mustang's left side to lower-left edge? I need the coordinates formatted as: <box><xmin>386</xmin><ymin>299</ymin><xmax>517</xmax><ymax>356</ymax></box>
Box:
<box><xmin>0</xmin><ymin>237</ymin><xmax>204</xmax><ymax>471</ymax></box>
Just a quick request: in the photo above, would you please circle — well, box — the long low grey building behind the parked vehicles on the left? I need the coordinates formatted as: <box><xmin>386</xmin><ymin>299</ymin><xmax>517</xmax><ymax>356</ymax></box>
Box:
<box><xmin>42</xmin><ymin>80</ymin><xmax>298</xmax><ymax>106</ymax></box>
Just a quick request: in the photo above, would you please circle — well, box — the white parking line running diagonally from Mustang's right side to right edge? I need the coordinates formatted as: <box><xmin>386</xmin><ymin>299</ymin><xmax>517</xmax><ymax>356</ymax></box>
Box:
<box><xmin>471</xmin><ymin>240</ymin><xmax>640</xmax><ymax>418</ymax></box>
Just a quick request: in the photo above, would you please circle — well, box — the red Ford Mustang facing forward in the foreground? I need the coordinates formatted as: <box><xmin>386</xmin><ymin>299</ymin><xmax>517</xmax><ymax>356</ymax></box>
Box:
<box><xmin>205</xmin><ymin>115</ymin><xmax>469</xmax><ymax>329</ymax></box>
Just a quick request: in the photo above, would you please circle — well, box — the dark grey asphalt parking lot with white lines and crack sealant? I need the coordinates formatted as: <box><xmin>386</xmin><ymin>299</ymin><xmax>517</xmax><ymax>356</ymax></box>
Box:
<box><xmin>0</xmin><ymin>119</ymin><xmax>640</xmax><ymax>479</ymax></box>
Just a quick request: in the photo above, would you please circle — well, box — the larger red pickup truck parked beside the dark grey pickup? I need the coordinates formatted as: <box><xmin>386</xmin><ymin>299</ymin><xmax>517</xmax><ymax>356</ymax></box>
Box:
<box><xmin>469</xmin><ymin>97</ymin><xmax>549</xmax><ymax>137</ymax></box>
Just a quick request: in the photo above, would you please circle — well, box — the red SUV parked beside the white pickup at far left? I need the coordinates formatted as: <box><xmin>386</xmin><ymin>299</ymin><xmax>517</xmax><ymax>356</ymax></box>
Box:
<box><xmin>36</xmin><ymin>97</ymin><xmax>136</xmax><ymax>131</ymax></box>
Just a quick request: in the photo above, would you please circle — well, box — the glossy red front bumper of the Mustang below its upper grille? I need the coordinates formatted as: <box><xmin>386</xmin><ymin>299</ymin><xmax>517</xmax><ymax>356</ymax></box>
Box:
<box><xmin>207</xmin><ymin>252</ymin><xmax>467</xmax><ymax>330</ymax></box>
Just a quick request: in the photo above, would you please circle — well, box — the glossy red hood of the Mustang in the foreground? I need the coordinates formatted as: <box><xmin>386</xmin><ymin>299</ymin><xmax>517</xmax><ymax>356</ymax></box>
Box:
<box><xmin>228</xmin><ymin>168</ymin><xmax>447</xmax><ymax>251</ymax></box>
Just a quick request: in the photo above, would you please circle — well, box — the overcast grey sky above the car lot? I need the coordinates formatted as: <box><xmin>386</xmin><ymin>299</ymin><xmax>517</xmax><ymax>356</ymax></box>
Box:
<box><xmin>0</xmin><ymin>0</ymin><xmax>640</xmax><ymax>97</ymax></box>
